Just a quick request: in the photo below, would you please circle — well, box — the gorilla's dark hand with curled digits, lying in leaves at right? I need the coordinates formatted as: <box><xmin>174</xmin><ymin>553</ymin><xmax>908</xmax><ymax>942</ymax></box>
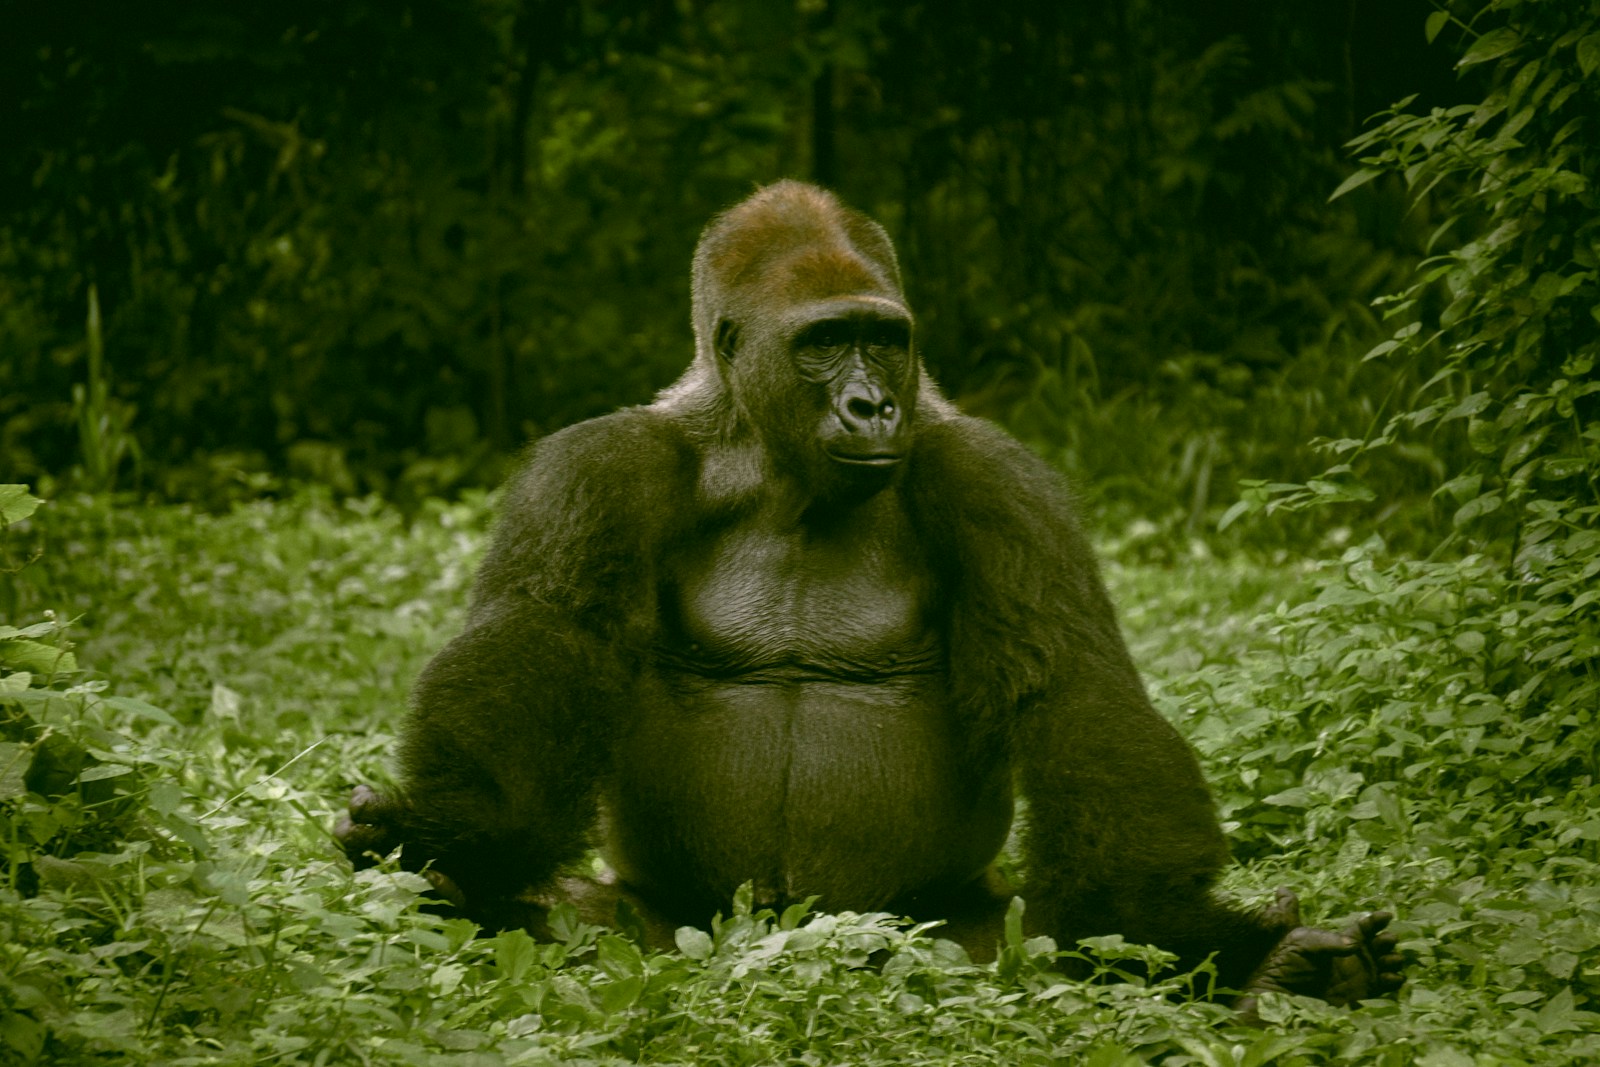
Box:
<box><xmin>1238</xmin><ymin>889</ymin><xmax>1405</xmax><ymax>1019</ymax></box>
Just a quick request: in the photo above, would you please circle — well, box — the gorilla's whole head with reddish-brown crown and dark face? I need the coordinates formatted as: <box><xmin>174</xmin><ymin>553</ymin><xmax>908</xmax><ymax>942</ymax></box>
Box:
<box><xmin>677</xmin><ymin>181</ymin><xmax>923</xmax><ymax>496</ymax></box>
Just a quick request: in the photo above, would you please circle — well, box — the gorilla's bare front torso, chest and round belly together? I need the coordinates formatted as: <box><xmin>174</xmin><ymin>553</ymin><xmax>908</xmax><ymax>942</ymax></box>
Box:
<box><xmin>606</xmin><ymin>505</ymin><xmax>1011</xmax><ymax>913</ymax></box>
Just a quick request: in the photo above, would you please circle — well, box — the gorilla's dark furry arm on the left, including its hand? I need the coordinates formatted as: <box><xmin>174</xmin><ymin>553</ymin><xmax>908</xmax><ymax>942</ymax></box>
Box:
<box><xmin>336</xmin><ymin>411</ymin><xmax>691</xmax><ymax>921</ymax></box>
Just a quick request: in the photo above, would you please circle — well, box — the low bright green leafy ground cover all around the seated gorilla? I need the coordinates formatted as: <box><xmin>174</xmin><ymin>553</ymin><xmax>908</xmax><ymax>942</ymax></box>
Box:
<box><xmin>0</xmin><ymin>491</ymin><xmax>1600</xmax><ymax>1067</ymax></box>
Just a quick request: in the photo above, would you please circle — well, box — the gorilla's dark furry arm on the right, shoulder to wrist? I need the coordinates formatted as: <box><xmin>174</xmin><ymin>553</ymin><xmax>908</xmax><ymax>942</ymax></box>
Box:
<box><xmin>910</xmin><ymin>418</ymin><xmax>1392</xmax><ymax>995</ymax></box>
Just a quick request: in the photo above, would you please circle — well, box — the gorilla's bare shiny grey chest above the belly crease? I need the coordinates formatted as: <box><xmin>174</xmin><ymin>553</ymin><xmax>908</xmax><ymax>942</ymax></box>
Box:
<box><xmin>662</xmin><ymin>511</ymin><xmax>939</xmax><ymax>681</ymax></box>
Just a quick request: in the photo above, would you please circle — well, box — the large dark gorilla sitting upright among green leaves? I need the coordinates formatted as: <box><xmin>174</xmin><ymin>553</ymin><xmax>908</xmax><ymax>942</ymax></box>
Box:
<box><xmin>336</xmin><ymin>181</ymin><xmax>1400</xmax><ymax>1003</ymax></box>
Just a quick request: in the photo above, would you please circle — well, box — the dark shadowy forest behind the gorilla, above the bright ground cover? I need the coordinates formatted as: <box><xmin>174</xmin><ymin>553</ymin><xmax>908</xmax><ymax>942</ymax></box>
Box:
<box><xmin>0</xmin><ymin>0</ymin><xmax>1482</xmax><ymax>525</ymax></box>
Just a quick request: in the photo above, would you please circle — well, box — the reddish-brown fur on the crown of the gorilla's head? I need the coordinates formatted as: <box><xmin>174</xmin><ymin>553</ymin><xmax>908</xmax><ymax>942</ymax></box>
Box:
<box><xmin>693</xmin><ymin>181</ymin><xmax>906</xmax><ymax>363</ymax></box>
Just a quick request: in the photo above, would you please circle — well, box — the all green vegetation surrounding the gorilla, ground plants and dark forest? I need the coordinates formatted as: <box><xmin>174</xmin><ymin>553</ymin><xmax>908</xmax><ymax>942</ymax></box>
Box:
<box><xmin>0</xmin><ymin>0</ymin><xmax>1600</xmax><ymax>1067</ymax></box>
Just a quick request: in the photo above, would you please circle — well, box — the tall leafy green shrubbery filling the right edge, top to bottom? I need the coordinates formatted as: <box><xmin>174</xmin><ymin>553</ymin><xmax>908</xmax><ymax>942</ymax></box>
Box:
<box><xmin>1170</xmin><ymin>8</ymin><xmax>1600</xmax><ymax>1062</ymax></box>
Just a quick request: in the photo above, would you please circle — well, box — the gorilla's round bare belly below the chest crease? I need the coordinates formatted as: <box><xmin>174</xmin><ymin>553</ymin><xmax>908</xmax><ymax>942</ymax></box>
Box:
<box><xmin>606</xmin><ymin>675</ymin><xmax>1011</xmax><ymax>913</ymax></box>
